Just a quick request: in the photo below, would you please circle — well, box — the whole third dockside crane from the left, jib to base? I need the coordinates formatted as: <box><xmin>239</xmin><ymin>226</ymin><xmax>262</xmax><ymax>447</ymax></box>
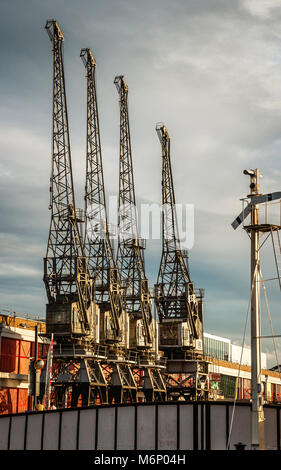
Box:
<box><xmin>114</xmin><ymin>75</ymin><xmax>166</xmax><ymax>400</ymax></box>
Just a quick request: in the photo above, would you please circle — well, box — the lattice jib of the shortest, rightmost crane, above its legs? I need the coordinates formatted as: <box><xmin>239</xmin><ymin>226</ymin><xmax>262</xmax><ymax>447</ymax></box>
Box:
<box><xmin>155</xmin><ymin>123</ymin><xmax>202</xmax><ymax>350</ymax></box>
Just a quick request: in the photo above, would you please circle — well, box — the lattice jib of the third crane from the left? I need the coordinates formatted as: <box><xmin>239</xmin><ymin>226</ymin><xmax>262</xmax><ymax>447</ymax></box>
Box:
<box><xmin>114</xmin><ymin>76</ymin><xmax>155</xmax><ymax>347</ymax></box>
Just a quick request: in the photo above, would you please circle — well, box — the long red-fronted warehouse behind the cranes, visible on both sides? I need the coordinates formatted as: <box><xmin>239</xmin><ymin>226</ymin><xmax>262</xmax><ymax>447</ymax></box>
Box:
<box><xmin>0</xmin><ymin>312</ymin><xmax>281</xmax><ymax>414</ymax></box>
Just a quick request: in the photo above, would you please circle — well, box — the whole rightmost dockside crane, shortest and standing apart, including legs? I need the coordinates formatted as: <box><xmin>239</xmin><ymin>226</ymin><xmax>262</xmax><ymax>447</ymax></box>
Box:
<box><xmin>155</xmin><ymin>123</ymin><xmax>207</xmax><ymax>398</ymax></box>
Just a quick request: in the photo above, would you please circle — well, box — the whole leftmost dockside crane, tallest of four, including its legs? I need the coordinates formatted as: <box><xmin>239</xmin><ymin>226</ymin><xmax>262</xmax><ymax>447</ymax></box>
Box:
<box><xmin>42</xmin><ymin>20</ymin><xmax>106</xmax><ymax>406</ymax></box>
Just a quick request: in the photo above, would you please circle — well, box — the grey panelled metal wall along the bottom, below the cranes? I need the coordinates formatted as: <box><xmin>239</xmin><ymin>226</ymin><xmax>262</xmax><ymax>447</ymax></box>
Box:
<box><xmin>0</xmin><ymin>402</ymin><xmax>280</xmax><ymax>451</ymax></box>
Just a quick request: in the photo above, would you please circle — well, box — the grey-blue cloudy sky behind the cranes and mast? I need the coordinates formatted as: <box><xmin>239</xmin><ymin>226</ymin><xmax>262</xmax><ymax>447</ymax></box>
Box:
<box><xmin>0</xmin><ymin>0</ymin><xmax>281</xmax><ymax>366</ymax></box>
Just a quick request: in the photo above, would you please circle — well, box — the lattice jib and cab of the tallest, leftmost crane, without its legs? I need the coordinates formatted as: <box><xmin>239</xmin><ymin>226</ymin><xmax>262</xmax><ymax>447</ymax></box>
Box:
<box><xmin>44</xmin><ymin>20</ymin><xmax>94</xmax><ymax>337</ymax></box>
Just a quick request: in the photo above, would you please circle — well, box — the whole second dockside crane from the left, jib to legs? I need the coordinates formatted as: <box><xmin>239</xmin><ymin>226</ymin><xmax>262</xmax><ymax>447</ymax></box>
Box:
<box><xmin>80</xmin><ymin>49</ymin><xmax>136</xmax><ymax>402</ymax></box>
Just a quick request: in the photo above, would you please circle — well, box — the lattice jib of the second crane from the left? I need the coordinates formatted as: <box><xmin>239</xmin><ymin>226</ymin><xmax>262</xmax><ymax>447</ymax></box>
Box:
<box><xmin>80</xmin><ymin>49</ymin><xmax>123</xmax><ymax>340</ymax></box>
